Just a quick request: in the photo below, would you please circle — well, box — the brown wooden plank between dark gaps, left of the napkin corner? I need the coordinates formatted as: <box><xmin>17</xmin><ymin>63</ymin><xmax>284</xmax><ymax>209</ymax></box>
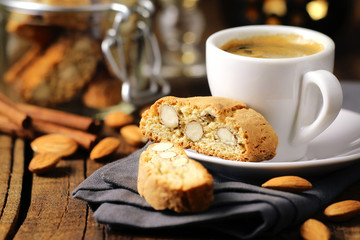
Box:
<box><xmin>14</xmin><ymin>154</ymin><xmax>86</xmax><ymax>239</ymax></box>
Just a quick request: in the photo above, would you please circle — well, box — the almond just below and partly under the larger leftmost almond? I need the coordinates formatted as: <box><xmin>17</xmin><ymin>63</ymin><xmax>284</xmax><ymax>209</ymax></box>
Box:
<box><xmin>28</xmin><ymin>152</ymin><xmax>61</xmax><ymax>174</ymax></box>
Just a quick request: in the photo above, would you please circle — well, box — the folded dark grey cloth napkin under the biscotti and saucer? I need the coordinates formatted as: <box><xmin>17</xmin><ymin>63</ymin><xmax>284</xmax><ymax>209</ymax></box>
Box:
<box><xmin>72</xmin><ymin>142</ymin><xmax>360</xmax><ymax>239</ymax></box>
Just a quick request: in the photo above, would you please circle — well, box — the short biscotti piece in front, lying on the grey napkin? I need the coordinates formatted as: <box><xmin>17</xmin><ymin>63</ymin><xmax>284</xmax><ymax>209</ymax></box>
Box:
<box><xmin>137</xmin><ymin>142</ymin><xmax>214</xmax><ymax>212</ymax></box>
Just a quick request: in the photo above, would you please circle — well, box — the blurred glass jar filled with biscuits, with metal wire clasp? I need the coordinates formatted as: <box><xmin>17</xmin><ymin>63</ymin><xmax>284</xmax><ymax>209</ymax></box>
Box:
<box><xmin>0</xmin><ymin>0</ymin><xmax>170</xmax><ymax>116</ymax></box>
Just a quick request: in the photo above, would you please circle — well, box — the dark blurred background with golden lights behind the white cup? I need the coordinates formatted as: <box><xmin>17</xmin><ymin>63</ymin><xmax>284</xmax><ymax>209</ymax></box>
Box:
<box><xmin>154</xmin><ymin>0</ymin><xmax>360</xmax><ymax>81</ymax></box>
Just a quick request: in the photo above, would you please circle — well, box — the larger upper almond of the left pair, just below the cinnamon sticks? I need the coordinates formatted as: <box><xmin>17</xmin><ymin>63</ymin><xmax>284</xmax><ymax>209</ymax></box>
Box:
<box><xmin>30</xmin><ymin>134</ymin><xmax>78</xmax><ymax>157</ymax></box>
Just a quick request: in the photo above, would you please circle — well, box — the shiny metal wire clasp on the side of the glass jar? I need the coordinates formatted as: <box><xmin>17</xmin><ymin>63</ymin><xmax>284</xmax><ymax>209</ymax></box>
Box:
<box><xmin>101</xmin><ymin>0</ymin><xmax>170</xmax><ymax>105</ymax></box>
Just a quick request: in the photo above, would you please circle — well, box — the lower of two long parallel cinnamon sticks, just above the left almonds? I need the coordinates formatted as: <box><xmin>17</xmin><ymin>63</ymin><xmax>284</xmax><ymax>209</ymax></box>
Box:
<box><xmin>32</xmin><ymin>119</ymin><xmax>97</xmax><ymax>150</ymax></box>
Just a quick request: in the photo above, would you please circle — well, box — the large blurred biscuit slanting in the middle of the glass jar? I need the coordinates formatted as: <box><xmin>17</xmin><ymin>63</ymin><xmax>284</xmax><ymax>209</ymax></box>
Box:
<box><xmin>4</xmin><ymin>34</ymin><xmax>101</xmax><ymax>106</ymax></box>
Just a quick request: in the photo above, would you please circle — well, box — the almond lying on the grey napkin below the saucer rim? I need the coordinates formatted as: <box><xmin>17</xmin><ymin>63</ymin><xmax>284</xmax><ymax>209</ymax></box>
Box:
<box><xmin>261</xmin><ymin>176</ymin><xmax>312</xmax><ymax>193</ymax></box>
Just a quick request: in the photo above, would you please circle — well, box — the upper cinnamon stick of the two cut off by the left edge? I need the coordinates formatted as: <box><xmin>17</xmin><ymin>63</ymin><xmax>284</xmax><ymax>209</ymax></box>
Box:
<box><xmin>0</xmin><ymin>93</ymin><xmax>31</xmax><ymax>128</ymax></box>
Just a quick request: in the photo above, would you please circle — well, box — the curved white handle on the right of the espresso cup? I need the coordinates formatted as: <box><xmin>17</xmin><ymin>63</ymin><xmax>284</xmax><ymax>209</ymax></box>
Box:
<box><xmin>292</xmin><ymin>70</ymin><xmax>343</xmax><ymax>145</ymax></box>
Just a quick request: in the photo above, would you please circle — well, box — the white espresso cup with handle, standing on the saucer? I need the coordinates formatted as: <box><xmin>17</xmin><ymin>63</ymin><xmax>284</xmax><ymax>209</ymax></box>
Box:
<box><xmin>206</xmin><ymin>25</ymin><xmax>343</xmax><ymax>161</ymax></box>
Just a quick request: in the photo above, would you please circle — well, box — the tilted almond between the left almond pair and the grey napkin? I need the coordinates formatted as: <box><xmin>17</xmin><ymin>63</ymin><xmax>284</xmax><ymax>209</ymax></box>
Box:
<box><xmin>90</xmin><ymin>137</ymin><xmax>121</xmax><ymax>160</ymax></box>
